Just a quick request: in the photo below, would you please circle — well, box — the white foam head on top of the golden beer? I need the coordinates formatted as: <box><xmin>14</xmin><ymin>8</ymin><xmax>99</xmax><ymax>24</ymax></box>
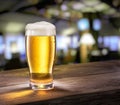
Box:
<box><xmin>25</xmin><ymin>21</ymin><xmax>56</xmax><ymax>36</ymax></box>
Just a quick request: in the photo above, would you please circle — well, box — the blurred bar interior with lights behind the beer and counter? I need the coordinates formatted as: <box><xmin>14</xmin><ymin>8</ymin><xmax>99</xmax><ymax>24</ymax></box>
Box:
<box><xmin>0</xmin><ymin>0</ymin><xmax>120</xmax><ymax>71</ymax></box>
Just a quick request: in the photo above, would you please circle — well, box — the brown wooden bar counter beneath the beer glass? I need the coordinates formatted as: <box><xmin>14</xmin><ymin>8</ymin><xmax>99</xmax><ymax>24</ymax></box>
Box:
<box><xmin>0</xmin><ymin>60</ymin><xmax>120</xmax><ymax>105</ymax></box>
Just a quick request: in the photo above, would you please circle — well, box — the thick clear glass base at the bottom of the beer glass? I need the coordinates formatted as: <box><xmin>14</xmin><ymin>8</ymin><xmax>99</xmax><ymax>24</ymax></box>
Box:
<box><xmin>30</xmin><ymin>83</ymin><xmax>54</xmax><ymax>90</ymax></box>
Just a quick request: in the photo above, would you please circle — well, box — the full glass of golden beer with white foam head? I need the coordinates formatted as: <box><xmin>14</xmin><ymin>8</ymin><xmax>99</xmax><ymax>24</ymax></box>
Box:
<box><xmin>25</xmin><ymin>21</ymin><xmax>56</xmax><ymax>90</ymax></box>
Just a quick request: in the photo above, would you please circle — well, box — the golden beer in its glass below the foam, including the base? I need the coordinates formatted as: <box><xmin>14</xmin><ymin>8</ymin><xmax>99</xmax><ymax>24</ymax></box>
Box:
<box><xmin>26</xmin><ymin>20</ymin><xmax>56</xmax><ymax>90</ymax></box>
